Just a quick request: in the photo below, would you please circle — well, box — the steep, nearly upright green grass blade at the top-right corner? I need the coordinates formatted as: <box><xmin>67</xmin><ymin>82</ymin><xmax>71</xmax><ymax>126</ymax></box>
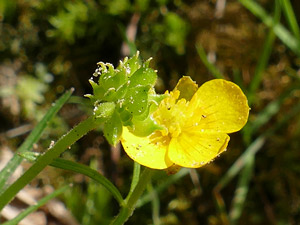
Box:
<box><xmin>280</xmin><ymin>0</ymin><xmax>300</xmax><ymax>42</ymax></box>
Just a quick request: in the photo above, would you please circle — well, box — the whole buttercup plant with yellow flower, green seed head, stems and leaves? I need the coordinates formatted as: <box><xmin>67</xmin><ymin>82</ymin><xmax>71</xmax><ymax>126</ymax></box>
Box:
<box><xmin>0</xmin><ymin>52</ymin><xmax>249</xmax><ymax>224</ymax></box>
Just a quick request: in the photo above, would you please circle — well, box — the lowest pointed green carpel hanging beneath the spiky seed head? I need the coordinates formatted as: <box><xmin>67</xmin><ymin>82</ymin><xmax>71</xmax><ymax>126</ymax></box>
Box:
<box><xmin>103</xmin><ymin>111</ymin><xmax>123</xmax><ymax>146</ymax></box>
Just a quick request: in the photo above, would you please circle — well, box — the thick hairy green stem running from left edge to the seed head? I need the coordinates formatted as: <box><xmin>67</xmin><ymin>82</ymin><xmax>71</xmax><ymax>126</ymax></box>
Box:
<box><xmin>0</xmin><ymin>116</ymin><xmax>99</xmax><ymax>211</ymax></box>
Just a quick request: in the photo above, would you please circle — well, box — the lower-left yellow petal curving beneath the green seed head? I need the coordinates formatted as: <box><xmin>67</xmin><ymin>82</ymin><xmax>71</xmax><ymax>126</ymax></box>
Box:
<box><xmin>121</xmin><ymin>127</ymin><xmax>173</xmax><ymax>169</ymax></box>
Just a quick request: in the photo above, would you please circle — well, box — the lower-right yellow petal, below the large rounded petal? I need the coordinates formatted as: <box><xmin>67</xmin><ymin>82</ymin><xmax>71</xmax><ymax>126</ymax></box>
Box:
<box><xmin>168</xmin><ymin>131</ymin><xmax>230</xmax><ymax>168</ymax></box>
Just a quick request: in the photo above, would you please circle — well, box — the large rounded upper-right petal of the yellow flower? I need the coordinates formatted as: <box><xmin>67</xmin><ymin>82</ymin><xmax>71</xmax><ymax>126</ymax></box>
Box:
<box><xmin>189</xmin><ymin>79</ymin><xmax>249</xmax><ymax>133</ymax></box>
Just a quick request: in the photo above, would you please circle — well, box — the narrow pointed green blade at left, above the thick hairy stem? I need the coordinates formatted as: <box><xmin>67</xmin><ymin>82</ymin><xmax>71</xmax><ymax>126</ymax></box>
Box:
<box><xmin>0</xmin><ymin>88</ymin><xmax>74</xmax><ymax>194</ymax></box>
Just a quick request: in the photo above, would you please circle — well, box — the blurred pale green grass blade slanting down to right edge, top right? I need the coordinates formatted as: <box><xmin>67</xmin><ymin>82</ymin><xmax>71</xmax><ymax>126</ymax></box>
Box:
<box><xmin>239</xmin><ymin>0</ymin><xmax>300</xmax><ymax>56</ymax></box>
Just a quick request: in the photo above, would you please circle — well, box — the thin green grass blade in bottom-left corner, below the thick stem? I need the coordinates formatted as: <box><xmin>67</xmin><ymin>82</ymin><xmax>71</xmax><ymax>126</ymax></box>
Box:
<box><xmin>2</xmin><ymin>185</ymin><xmax>69</xmax><ymax>225</ymax></box>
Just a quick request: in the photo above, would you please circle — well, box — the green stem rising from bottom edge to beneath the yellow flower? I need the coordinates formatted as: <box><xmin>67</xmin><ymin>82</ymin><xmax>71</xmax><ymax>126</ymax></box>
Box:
<box><xmin>111</xmin><ymin>168</ymin><xmax>154</xmax><ymax>225</ymax></box>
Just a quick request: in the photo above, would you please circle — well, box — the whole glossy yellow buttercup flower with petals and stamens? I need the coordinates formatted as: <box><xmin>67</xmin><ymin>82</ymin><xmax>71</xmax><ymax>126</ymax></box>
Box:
<box><xmin>121</xmin><ymin>77</ymin><xmax>249</xmax><ymax>169</ymax></box>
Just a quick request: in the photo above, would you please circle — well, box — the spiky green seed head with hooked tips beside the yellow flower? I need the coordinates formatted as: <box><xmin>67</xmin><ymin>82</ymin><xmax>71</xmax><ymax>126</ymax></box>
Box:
<box><xmin>85</xmin><ymin>52</ymin><xmax>165</xmax><ymax>145</ymax></box>
